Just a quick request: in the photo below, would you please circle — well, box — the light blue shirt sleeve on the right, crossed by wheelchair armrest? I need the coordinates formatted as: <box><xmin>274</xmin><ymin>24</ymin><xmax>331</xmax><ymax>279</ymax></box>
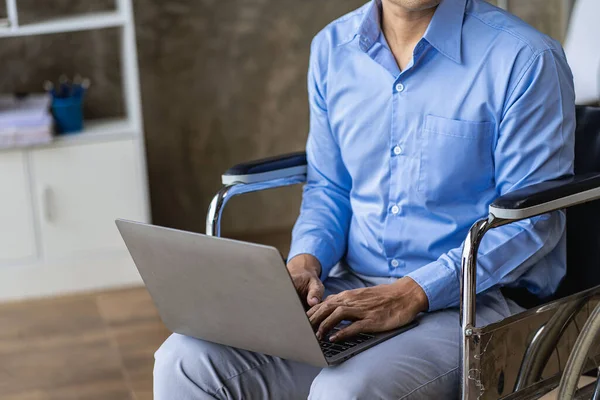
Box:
<box><xmin>408</xmin><ymin>49</ymin><xmax>575</xmax><ymax>311</ymax></box>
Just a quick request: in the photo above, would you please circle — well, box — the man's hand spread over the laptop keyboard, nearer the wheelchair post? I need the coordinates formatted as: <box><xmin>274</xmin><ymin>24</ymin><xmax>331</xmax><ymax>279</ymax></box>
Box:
<box><xmin>307</xmin><ymin>277</ymin><xmax>429</xmax><ymax>341</ymax></box>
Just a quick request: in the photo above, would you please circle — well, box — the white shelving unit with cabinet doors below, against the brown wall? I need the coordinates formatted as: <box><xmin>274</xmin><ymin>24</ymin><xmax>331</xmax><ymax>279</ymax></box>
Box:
<box><xmin>0</xmin><ymin>0</ymin><xmax>150</xmax><ymax>302</ymax></box>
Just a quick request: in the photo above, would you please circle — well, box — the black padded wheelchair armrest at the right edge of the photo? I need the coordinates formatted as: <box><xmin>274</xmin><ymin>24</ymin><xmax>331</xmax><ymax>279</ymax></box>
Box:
<box><xmin>489</xmin><ymin>173</ymin><xmax>600</xmax><ymax>220</ymax></box>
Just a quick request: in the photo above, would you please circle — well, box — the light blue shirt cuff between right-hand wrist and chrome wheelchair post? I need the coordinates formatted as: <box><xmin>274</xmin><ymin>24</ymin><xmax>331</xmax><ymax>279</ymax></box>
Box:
<box><xmin>407</xmin><ymin>260</ymin><xmax>460</xmax><ymax>312</ymax></box>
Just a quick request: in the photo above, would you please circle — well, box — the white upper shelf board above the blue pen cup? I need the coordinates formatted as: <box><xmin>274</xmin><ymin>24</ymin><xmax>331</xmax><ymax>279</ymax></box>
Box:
<box><xmin>0</xmin><ymin>11</ymin><xmax>126</xmax><ymax>38</ymax></box>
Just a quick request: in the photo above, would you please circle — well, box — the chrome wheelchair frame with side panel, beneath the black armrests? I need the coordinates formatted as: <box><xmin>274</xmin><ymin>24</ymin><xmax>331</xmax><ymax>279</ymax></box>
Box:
<box><xmin>206</xmin><ymin>170</ymin><xmax>600</xmax><ymax>400</ymax></box>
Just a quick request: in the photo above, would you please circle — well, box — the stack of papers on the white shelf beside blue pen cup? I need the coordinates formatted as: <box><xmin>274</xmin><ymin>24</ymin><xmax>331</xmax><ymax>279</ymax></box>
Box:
<box><xmin>0</xmin><ymin>94</ymin><xmax>53</xmax><ymax>148</ymax></box>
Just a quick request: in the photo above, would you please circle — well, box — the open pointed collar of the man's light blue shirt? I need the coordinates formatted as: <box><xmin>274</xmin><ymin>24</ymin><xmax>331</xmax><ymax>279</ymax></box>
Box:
<box><xmin>357</xmin><ymin>0</ymin><xmax>467</xmax><ymax>63</ymax></box>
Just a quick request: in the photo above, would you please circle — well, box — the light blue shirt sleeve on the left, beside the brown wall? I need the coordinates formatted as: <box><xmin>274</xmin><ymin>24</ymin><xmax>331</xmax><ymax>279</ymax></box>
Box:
<box><xmin>288</xmin><ymin>40</ymin><xmax>352</xmax><ymax>279</ymax></box>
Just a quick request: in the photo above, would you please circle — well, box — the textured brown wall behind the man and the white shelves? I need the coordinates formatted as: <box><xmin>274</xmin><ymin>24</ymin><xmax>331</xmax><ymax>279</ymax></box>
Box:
<box><xmin>0</xmin><ymin>0</ymin><xmax>561</xmax><ymax>236</ymax></box>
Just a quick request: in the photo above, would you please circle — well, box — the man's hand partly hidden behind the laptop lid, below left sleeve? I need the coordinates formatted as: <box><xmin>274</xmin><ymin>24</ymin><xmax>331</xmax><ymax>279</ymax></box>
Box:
<box><xmin>287</xmin><ymin>254</ymin><xmax>325</xmax><ymax>307</ymax></box>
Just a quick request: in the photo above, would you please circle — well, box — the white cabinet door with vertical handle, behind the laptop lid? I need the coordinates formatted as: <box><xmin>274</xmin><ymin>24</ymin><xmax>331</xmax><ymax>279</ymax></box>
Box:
<box><xmin>32</xmin><ymin>140</ymin><xmax>145</xmax><ymax>258</ymax></box>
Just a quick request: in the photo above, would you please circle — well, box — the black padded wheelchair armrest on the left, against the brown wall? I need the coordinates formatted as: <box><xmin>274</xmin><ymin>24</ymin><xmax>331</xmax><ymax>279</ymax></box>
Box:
<box><xmin>221</xmin><ymin>151</ymin><xmax>306</xmax><ymax>185</ymax></box>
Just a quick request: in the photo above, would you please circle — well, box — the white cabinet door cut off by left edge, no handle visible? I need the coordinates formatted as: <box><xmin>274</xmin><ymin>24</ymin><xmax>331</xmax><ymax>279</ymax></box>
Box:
<box><xmin>0</xmin><ymin>151</ymin><xmax>36</xmax><ymax>264</ymax></box>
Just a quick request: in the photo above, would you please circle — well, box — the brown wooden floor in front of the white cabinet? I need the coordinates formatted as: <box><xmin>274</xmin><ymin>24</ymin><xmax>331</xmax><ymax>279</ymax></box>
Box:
<box><xmin>0</xmin><ymin>288</ymin><xmax>169</xmax><ymax>400</ymax></box>
